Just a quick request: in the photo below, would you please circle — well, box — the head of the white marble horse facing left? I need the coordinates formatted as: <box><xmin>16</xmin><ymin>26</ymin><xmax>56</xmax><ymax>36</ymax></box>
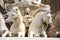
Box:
<box><xmin>6</xmin><ymin>7</ymin><xmax>19</xmax><ymax>22</ymax></box>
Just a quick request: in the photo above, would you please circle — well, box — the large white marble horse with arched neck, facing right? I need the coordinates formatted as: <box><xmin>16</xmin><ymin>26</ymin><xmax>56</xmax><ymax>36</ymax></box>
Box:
<box><xmin>28</xmin><ymin>5</ymin><xmax>50</xmax><ymax>37</ymax></box>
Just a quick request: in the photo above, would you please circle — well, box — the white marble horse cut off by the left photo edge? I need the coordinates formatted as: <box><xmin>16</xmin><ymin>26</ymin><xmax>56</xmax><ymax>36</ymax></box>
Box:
<box><xmin>0</xmin><ymin>12</ymin><xmax>9</xmax><ymax>37</ymax></box>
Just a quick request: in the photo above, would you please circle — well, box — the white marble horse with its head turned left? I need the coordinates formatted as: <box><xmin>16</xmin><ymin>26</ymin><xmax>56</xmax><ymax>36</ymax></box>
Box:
<box><xmin>6</xmin><ymin>6</ymin><xmax>25</xmax><ymax>37</ymax></box>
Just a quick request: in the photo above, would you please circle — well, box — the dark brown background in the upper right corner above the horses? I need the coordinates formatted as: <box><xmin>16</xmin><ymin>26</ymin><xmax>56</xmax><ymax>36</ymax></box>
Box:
<box><xmin>42</xmin><ymin>0</ymin><xmax>60</xmax><ymax>14</ymax></box>
